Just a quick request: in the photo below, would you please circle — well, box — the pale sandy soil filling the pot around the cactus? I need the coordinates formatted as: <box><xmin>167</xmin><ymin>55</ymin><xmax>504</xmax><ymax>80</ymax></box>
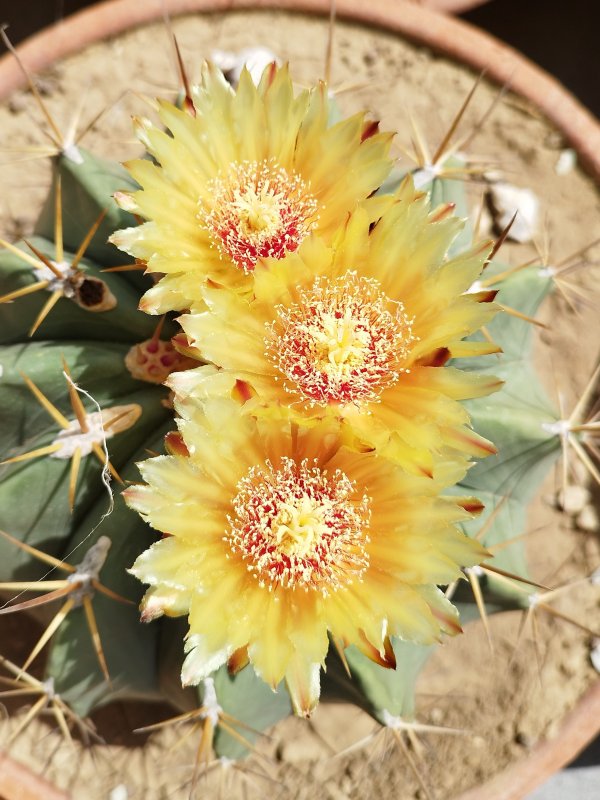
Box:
<box><xmin>0</xmin><ymin>7</ymin><xmax>600</xmax><ymax>800</ymax></box>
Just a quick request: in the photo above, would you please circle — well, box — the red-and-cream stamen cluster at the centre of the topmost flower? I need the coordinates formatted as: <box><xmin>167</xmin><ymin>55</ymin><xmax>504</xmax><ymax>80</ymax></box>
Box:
<box><xmin>198</xmin><ymin>160</ymin><xmax>318</xmax><ymax>273</ymax></box>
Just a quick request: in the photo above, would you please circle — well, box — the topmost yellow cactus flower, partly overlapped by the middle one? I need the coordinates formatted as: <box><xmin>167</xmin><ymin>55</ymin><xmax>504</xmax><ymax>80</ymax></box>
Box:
<box><xmin>112</xmin><ymin>64</ymin><xmax>391</xmax><ymax>314</ymax></box>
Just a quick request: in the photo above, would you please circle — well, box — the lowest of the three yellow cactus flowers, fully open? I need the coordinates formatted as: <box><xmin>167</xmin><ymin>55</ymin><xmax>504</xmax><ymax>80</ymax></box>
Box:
<box><xmin>125</xmin><ymin>398</ymin><xmax>486</xmax><ymax>714</ymax></box>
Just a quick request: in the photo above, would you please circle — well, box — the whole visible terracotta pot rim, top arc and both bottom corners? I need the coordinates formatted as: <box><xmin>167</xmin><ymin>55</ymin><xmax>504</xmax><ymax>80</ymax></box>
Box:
<box><xmin>0</xmin><ymin>0</ymin><xmax>600</xmax><ymax>800</ymax></box>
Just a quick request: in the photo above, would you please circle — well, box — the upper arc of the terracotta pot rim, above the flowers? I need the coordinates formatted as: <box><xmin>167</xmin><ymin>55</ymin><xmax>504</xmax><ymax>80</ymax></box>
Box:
<box><xmin>0</xmin><ymin>0</ymin><xmax>600</xmax><ymax>180</ymax></box>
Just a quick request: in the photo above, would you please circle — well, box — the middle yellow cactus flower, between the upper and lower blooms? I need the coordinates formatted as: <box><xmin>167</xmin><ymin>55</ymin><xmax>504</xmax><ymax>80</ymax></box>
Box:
<box><xmin>169</xmin><ymin>180</ymin><xmax>500</xmax><ymax>475</ymax></box>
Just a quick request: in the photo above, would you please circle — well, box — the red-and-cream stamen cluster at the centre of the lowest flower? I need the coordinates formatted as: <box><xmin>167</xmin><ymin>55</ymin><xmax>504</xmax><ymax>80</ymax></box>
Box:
<box><xmin>230</xmin><ymin>458</ymin><xmax>370</xmax><ymax>595</ymax></box>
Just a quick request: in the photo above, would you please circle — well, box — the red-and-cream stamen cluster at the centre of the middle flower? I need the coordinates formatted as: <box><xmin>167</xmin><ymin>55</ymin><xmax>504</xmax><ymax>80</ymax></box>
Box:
<box><xmin>266</xmin><ymin>272</ymin><xmax>417</xmax><ymax>406</ymax></box>
